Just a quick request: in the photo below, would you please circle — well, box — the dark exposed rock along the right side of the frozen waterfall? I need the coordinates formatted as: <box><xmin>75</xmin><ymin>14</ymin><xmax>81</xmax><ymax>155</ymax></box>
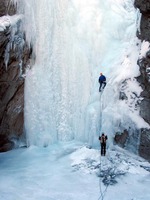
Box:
<box><xmin>114</xmin><ymin>0</ymin><xmax>150</xmax><ymax>161</ymax></box>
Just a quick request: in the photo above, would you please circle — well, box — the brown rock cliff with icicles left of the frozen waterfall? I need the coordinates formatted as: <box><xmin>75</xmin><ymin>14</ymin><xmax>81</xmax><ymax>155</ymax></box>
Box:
<box><xmin>0</xmin><ymin>0</ymin><xmax>30</xmax><ymax>151</ymax></box>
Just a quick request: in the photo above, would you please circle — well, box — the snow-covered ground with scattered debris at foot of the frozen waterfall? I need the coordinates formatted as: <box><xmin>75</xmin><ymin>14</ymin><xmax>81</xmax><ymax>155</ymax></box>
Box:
<box><xmin>0</xmin><ymin>142</ymin><xmax>150</xmax><ymax>200</ymax></box>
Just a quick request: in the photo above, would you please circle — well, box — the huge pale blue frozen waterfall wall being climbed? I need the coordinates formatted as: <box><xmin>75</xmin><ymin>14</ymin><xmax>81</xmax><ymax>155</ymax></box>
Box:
<box><xmin>15</xmin><ymin>0</ymin><xmax>143</xmax><ymax>146</ymax></box>
